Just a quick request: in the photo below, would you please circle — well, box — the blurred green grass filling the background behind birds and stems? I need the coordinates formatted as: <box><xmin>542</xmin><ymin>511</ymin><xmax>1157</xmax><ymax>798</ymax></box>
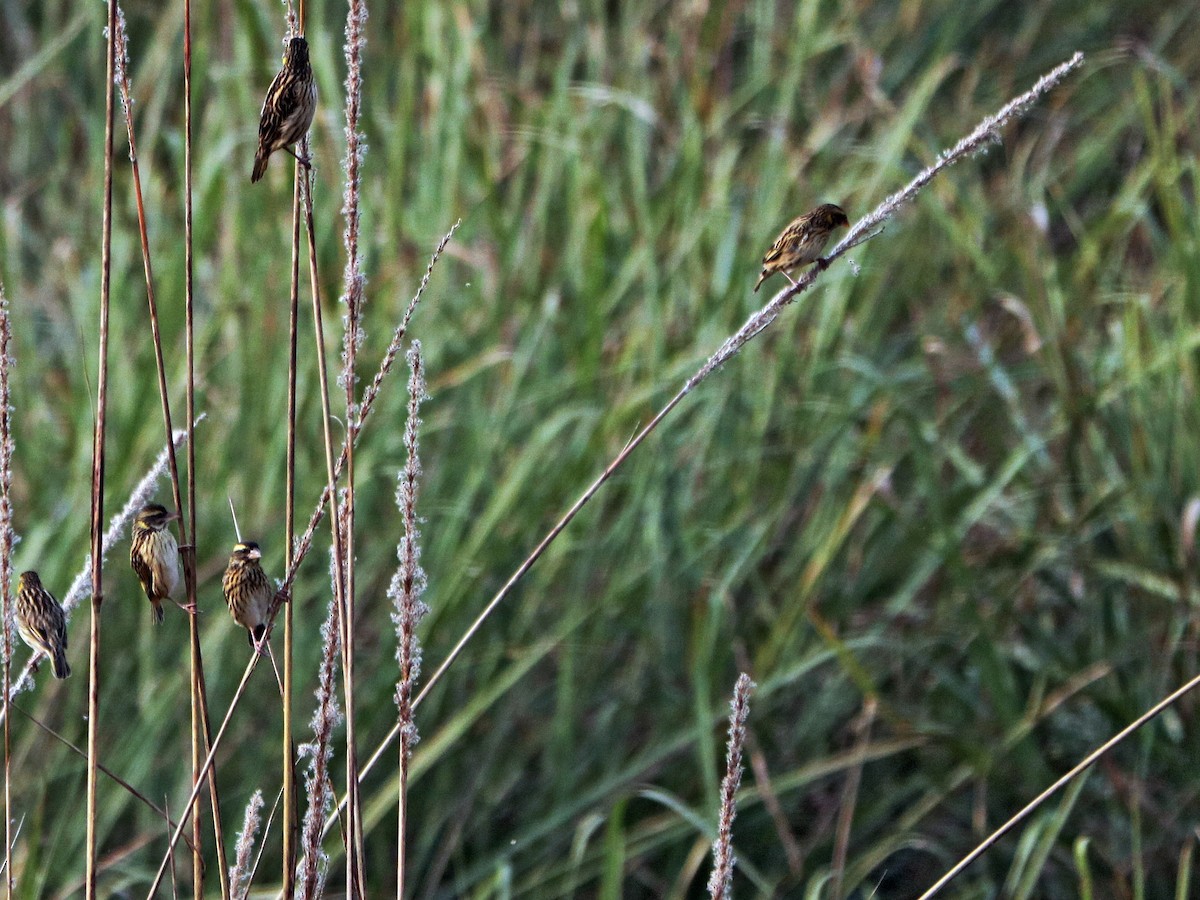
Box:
<box><xmin>0</xmin><ymin>0</ymin><xmax>1200</xmax><ymax>898</ymax></box>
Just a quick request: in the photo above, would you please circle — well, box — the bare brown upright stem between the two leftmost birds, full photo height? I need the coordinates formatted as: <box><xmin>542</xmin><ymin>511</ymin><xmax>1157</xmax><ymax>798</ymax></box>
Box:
<box><xmin>87</xmin><ymin>0</ymin><xmax>116</xmax><ymax>900</ymax></box>
